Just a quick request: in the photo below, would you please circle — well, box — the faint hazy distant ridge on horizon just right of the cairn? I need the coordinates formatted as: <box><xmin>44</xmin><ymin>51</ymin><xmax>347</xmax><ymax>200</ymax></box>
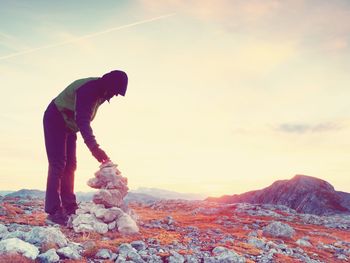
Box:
<box><xmin>131</xmin><ymin>187</ymin><xmax>206</xmax><ymax>200</ymax></box>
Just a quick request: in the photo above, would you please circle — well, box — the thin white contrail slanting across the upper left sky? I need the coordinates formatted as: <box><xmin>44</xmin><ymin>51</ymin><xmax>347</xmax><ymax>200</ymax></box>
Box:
<box><xmin>0</xmin><ymin>13</ymin><xmax>175</xmax><ymax>60</ymax></box>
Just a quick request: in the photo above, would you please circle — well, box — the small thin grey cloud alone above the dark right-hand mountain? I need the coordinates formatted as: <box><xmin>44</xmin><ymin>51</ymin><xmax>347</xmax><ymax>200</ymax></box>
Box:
<box><xmin>277</xmin><ymin>122</ymin><xmax>343</xmax><ymax>134</ymax></box>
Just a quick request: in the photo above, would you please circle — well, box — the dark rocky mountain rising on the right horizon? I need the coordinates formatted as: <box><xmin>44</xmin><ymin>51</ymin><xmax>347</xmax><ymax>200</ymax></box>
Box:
<box><xmin>206</xmin><ymin>175</ymin><xmax>350</xmax><ymax>215</ymax></box>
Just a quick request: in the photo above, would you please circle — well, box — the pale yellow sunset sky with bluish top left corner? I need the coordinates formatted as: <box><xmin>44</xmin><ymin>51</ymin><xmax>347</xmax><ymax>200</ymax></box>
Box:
<box><xmin>0</xmin><ymin>0</ymin><xmax>350</xmax><ymax>196</ymax></box>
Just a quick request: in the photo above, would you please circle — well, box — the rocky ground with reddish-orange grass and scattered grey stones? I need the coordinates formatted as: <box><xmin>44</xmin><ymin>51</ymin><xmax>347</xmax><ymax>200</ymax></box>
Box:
<box><xmin>0</xmin><ymin>197</ymin><xmax>350</xmax><ymax>263</ymax></box>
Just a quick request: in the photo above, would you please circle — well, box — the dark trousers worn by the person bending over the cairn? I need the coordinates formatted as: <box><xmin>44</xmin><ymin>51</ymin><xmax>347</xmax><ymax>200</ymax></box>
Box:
<box><xmin>43</xmin><ymin>101</ymin><xmax>77</xmax><ymax>214</ymax></box>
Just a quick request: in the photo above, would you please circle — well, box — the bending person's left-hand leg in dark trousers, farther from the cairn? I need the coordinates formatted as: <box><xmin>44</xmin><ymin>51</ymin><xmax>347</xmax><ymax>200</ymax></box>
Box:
<box><xmin>44</xmin><ymin>102</ymin><xmax>67</xmax><ymax>214</ymax></box>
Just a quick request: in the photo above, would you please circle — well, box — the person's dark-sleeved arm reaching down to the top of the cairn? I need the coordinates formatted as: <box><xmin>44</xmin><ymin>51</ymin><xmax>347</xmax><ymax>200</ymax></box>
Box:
<box><xmin>75</xmin><ymin>80</ymin><xmax>108</xmax><ymax>162</ymax></box>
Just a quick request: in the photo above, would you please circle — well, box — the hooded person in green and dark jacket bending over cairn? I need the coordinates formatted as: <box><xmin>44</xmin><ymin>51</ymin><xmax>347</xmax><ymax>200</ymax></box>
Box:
<box><xmin>43</xmin><ymin>70</ymin><xmax>128</xmax><ymax>225</ymax></box>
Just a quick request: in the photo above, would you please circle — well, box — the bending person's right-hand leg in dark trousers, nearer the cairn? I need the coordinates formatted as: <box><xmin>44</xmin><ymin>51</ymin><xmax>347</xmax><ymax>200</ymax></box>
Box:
<box><xmin>61</xmin><ymin>133</ymin><xmax>77</xmax><ymax>214</ymax></box>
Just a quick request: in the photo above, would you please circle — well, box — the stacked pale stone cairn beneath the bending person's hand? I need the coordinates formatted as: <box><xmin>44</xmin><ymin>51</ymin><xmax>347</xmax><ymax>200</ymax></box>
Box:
<box><xmin>69</xmin><ymin>162</ymin><xmax>139</xmax><ymax>234</ymax></box>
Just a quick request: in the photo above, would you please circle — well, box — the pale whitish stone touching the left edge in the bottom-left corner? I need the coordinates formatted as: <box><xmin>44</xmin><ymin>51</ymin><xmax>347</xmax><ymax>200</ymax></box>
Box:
<box><xmin>0</xmin><ymin>238</ymin><xmax>39</xmax><ymax>260</ymax></box>
